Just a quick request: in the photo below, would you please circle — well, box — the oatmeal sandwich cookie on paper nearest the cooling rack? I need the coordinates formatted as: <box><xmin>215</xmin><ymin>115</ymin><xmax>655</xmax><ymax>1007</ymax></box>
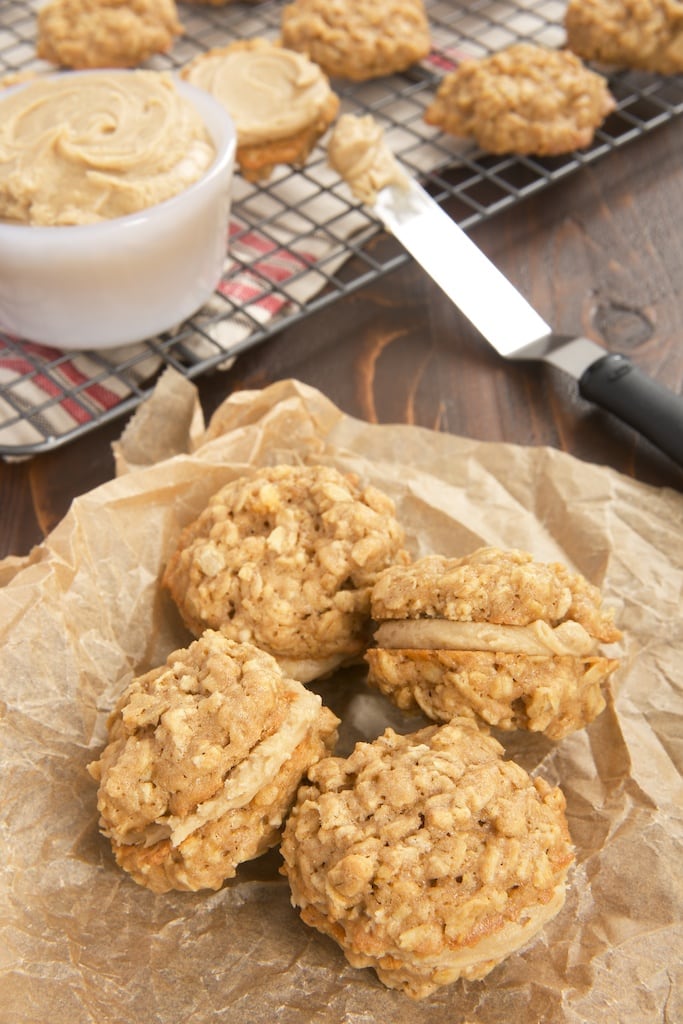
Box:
<box><xmin>163</xmin><ymin>466</ymin><xmax>408</xmax><ymax>681</ymax></box>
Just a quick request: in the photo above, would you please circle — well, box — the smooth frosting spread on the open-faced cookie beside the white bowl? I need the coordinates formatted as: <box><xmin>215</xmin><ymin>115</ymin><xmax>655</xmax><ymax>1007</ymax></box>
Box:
<box><xmin>184</xmin><ymin>41</ymin><xmax>331</xmax><ymax>146</ymax></box>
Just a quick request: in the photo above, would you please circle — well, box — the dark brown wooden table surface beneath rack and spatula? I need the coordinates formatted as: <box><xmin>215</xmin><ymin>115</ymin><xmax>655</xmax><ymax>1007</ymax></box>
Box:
<box><xmin>0</xmin><ymin>119</ymin><xmax>683</xmax><ymax>557</ymax></box>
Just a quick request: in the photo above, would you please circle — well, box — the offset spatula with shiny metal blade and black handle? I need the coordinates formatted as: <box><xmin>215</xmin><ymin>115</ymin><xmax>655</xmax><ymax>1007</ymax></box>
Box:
<box><xmin>373</xmin><ymin>179</ymin><xmax>683</xmax><ymax>465</ymax></box>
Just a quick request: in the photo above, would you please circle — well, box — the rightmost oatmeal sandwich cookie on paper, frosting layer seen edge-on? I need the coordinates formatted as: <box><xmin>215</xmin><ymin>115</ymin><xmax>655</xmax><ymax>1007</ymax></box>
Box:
<box><xmin>366</xmin><ymin>548</ymin><xmax>621</xmax><ymax>739</ymax></box>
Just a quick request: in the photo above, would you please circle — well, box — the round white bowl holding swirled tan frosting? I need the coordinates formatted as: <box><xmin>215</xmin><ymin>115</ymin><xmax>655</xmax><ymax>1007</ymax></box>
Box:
<box><xmin>0</xmin><ymin>72</ymin><xmax>237</xmax><ymax>349</ymax></box>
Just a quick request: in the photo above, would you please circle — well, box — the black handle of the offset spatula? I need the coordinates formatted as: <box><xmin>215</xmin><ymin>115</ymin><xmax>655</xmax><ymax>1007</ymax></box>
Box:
<box><xmin>579</xmin><ymin>352</ymin><xmax>683</xmax><ymax>466</ymax></box>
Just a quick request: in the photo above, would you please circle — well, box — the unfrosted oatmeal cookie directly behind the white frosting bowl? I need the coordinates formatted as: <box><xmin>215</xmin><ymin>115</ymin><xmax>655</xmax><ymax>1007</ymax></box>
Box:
<box><xmin>36</xmin><ymin>0</ymin><xmax>183</xmax><ymax>70</ymax></box>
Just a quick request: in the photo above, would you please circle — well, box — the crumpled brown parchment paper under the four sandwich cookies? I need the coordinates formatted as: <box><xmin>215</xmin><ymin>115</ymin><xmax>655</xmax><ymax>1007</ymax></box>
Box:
<box><xmin>0</xmin><ymin>381</ymin><xmax>683</xmax><ymax>1024</ymax></box>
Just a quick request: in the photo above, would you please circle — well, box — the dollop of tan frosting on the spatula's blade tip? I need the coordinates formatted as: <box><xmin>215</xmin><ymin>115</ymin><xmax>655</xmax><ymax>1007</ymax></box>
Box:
<box><xmin>328</xmin><ymin>114</ymin><xmax>408</xmax><ymax>205</ymax></box>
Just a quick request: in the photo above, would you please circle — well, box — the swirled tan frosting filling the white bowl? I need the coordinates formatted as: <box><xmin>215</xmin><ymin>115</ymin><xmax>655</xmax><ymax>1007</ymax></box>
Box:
<box><xmin>0</xmin><ymin>71</ymin><xmax>215</xmax><ymax>225</ymax></box>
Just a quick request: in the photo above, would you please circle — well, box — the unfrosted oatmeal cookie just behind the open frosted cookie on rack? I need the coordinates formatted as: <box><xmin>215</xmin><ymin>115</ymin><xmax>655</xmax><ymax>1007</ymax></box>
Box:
<box><xmin>281</xmin><ymin>0</ymin><xmax>430</xmax><ymax>82</ymax></box>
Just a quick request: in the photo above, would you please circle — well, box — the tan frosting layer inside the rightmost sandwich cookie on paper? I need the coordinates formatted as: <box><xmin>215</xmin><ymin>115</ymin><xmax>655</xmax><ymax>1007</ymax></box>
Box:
<box><xmin>375</xmin><ymin>618</ymin><xmax>597</xmax><ymax>657</ymax></box>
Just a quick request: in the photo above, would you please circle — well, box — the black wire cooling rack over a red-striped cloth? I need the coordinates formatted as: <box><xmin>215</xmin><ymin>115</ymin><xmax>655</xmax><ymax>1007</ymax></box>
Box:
<box><xmin>0</xmin><ymin>0</ymin><xmax>683</xmax><ymax>459</ymax></box>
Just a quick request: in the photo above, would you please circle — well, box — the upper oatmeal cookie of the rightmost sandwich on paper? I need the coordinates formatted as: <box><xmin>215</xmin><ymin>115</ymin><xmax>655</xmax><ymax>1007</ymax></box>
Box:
<box><xmin>372</xmin><ymin>547</ymin><xmax>621</xmax><ymax>653</ymax></box>
